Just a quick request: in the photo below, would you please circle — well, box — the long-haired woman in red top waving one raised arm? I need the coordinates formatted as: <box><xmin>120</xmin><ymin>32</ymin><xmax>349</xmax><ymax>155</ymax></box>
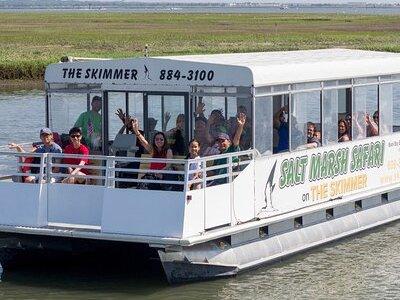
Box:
<box><xmin>131</xmin><ymin>119</ymin><xmax>173</xmax><ymax>189</ymax></box>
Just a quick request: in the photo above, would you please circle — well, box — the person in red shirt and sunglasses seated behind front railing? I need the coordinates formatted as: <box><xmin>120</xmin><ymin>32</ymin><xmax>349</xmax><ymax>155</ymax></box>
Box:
<box><xmin>61</xmin><ymin>127</ymin><xmax>89</xmax><ymax>184</ymax></box>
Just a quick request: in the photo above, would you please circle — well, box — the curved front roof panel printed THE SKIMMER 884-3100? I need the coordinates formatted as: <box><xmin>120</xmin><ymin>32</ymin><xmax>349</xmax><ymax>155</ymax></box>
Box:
<box><xmin>45</xmin><ymin>58</ymin><xmax>253</xmax><ymax>86</ymax></box>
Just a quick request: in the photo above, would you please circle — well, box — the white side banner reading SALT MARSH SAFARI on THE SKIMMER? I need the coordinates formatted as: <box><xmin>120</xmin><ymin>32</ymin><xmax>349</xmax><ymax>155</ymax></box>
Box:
<box><xmin>255</xmin><ymin>134</ymin><xmax>400</xmax><ymax>212</ymax></box>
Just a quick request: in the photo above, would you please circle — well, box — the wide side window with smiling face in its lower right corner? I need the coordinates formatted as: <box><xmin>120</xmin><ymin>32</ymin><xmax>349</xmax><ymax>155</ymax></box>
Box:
<box><xmin>290</xmin><ymin>91</ymin><xmax>321</xmax><ymax>150</ymax></box>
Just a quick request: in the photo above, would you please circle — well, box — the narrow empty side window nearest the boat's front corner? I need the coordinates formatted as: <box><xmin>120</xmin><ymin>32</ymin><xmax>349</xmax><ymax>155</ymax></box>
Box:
<box><xmin>254</xmin><ymin>96</ymin><xmax>272</xmax><ymax>155</ymax></box>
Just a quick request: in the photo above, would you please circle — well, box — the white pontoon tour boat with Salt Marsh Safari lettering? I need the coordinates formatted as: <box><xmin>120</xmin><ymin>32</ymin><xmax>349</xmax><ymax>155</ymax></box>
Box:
<box><xmin>0</xmin><ymin>49</ymin><xmax>400</xmax><ymax>283</ymax></box>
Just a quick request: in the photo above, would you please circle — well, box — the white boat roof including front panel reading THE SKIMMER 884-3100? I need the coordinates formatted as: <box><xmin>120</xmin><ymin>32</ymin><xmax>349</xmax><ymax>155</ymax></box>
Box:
<box><xmin>45</xmin><ymin>49</ymin><xmax>400</xmax><ymax>86</ymax></box>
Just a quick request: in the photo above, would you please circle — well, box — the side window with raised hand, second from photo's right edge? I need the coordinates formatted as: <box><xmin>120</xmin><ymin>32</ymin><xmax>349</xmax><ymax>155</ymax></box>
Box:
<box><xmin>351</xmin><ymin>85</ymin><xmax>379</xmax><ymax>140</ymax></box>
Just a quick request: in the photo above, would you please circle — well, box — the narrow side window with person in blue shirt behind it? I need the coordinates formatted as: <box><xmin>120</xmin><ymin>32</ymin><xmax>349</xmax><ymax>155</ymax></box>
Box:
<box><xmin>272</xmin><ymin>94</ymin><xmax>290</xmax><ymax>153</ymax></box>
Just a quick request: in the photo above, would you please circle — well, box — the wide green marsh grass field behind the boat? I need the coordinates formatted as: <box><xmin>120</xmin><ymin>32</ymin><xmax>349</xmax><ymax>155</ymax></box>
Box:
<box><xmin>0</xmin><ymin>12</ymin><xmax>400</xmax><ymax>79</ymax></box>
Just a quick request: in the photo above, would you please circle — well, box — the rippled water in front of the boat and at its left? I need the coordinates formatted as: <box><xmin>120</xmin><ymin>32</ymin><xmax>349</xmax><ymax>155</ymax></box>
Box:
<box><xmin>0</xmin><ymin>91</ymin><xmax>400</xmax><ymax>300</ymax></box>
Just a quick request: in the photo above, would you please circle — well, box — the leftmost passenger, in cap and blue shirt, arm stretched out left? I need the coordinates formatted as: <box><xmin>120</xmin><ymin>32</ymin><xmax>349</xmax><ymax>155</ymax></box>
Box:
<box><xmin>9</xmin><ymin>128</ymin><xmax>62</xmax><ymax>183</ymax></box>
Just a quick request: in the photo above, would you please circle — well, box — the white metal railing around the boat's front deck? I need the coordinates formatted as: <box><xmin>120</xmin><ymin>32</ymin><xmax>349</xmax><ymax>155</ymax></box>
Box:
<box><xmin>0</xmin><ymin>150</ymin><xmax>254</xmax><ymax>191</ymax></box>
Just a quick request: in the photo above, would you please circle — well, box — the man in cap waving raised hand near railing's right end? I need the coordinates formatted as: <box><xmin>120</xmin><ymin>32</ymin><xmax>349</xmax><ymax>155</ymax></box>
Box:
<box><xmin>211</xmin><ymin>113</ymin><xmax>246</xmax><ymax>185</ymax></box>
